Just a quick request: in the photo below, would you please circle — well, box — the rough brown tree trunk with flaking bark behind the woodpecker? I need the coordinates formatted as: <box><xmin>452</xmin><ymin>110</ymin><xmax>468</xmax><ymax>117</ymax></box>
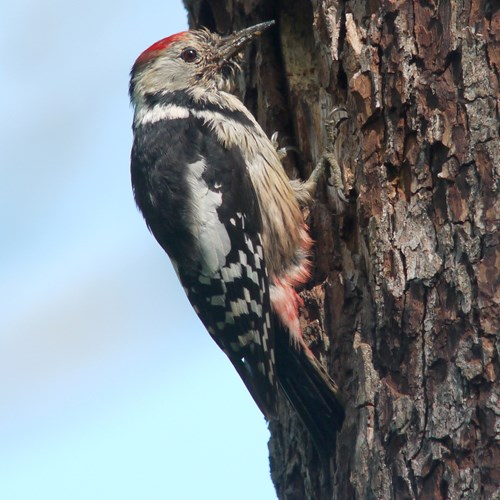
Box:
<box><xmin>186</xmin><ymin>0</ymin><xmax>500</xmax><ymax>500</ymax></box>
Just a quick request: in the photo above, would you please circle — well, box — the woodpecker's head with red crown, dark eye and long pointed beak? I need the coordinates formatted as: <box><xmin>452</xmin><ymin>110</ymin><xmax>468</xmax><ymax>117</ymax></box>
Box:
<box><xmin>130</xmin><ymin>21</ymin><xmax>274</xmax><ymax>104</ymax></box>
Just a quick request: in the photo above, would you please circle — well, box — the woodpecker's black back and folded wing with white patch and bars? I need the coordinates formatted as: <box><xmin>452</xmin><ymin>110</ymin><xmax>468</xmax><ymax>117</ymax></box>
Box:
<box><xmin>132</xmin><ymin>99</ymin><xmax>276</xmax><ymax>408</ymax></box>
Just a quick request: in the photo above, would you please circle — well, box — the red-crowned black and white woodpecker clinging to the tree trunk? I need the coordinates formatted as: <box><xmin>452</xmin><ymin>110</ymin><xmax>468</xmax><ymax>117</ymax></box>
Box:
<box><xmin>129</xmin><ymin>21</ymin><xmax>342</xmax><ymax>444</ymax></box>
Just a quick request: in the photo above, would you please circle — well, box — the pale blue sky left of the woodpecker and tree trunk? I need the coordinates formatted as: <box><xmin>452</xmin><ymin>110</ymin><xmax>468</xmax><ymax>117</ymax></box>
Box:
<box><xmin>0</xmin><ymin>0</ymin><xmax>276</xmax><ymax>500</ymax></box>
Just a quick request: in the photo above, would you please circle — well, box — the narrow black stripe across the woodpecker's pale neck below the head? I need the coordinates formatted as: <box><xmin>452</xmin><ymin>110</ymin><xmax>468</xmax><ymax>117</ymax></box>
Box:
<box><xmin>145</xmin><ymin>90</ymin><xmax>254</xmax><ymax>128</ymax></box>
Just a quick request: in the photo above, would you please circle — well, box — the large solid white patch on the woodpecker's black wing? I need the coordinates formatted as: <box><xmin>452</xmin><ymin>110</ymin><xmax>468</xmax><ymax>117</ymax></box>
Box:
<box><xmin>187</xmin><ymin>160</ymin><xmax>231</xmax><ymax>274</ymax></box>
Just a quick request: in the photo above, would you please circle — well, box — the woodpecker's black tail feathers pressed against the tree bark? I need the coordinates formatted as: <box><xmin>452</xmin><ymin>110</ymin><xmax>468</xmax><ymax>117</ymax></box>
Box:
<box><xmin>275</xmin><ymin>328</ymin><xmax>344</xmax><ymax>453</ymax></box>
